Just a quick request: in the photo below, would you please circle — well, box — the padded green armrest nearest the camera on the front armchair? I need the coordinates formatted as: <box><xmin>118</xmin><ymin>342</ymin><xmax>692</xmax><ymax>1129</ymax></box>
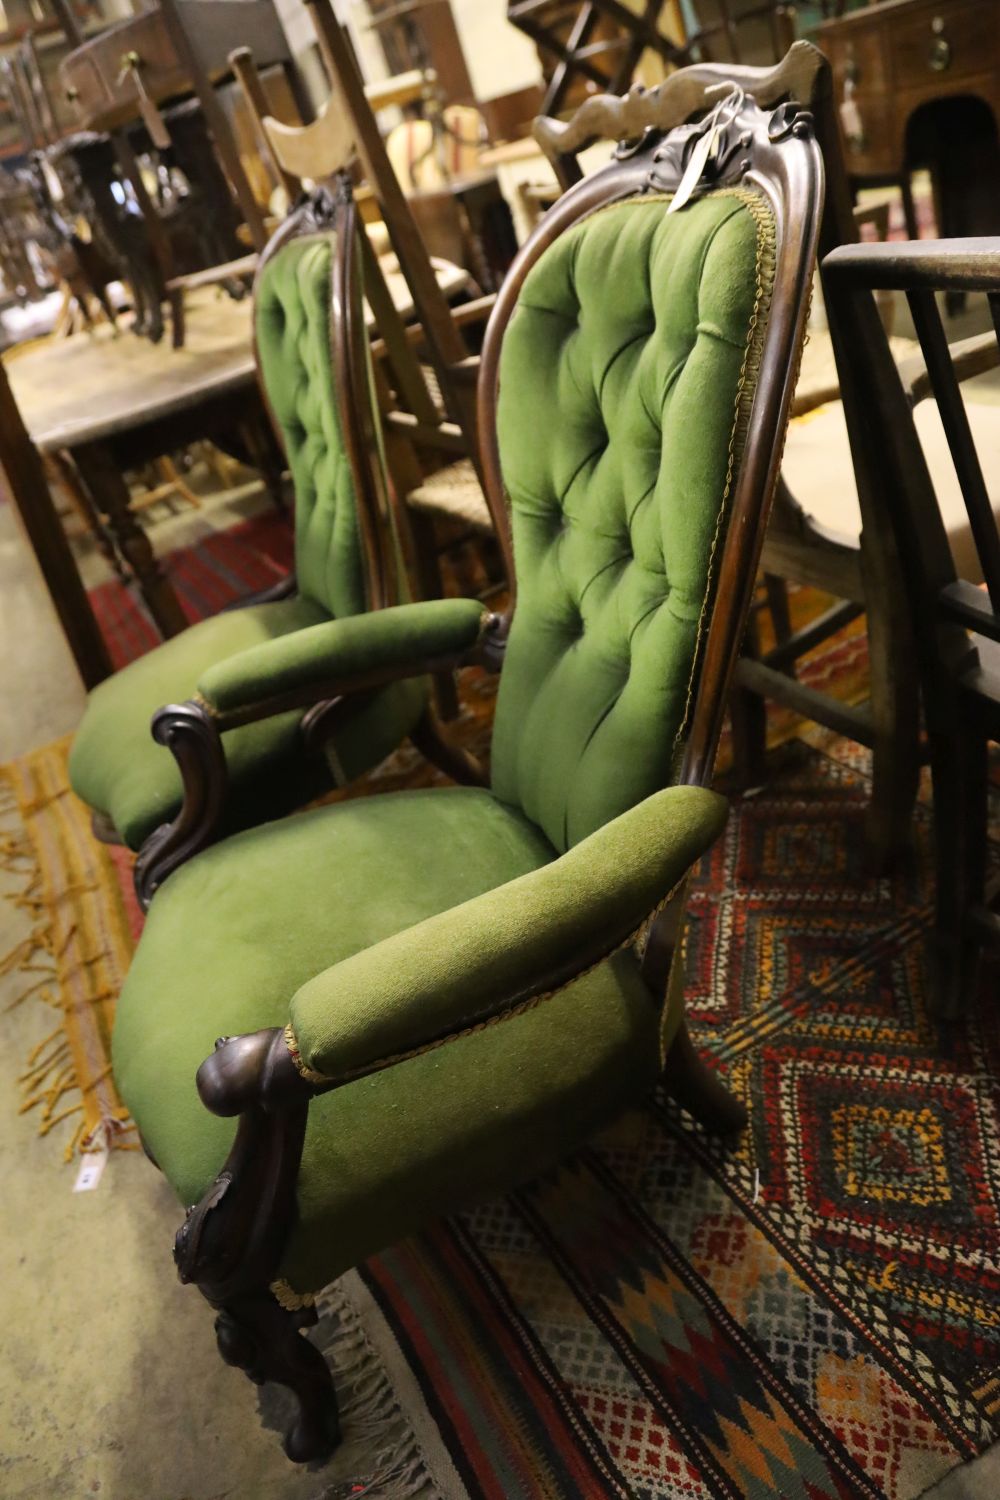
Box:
<box><xmin>288</xmin><ymin>786</ymin><xmax>727</xmax><ymax>1083</ymax></box>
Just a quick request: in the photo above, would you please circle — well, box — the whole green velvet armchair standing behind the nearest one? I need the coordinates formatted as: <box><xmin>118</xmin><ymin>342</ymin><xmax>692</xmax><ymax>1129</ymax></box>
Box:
<box><xmin>69</xmin><ymin>179</ymin><xmax>446</xmax><ymax>905</ymax></box>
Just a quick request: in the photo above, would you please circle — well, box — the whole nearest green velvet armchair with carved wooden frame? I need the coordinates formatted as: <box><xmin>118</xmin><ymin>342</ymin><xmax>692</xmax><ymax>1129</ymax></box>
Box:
<box><xmin>114</xmin><ymin>50</ymin><xmax>825</xmax><ymax>1460</ymax></box>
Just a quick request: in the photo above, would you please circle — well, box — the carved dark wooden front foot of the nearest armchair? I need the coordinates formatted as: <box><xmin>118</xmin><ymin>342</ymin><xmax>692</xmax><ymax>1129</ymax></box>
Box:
<box><xmin>209</xmin><ymin>1292</ymin><xmax>340</xmax><ymax>1464</ymax></box>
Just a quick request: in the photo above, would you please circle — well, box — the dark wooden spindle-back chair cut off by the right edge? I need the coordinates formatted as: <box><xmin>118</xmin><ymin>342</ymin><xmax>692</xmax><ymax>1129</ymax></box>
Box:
<box><xmin>825</xmin><ymin>239</ymin><xmax>1000</xmax><ymax>1017</ymax></box>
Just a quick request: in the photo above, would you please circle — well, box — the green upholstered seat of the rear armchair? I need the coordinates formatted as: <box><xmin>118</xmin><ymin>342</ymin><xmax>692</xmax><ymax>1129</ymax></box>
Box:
<box><xmin>69</xmin><ymin>597</ymin><xmax>426</xmax><ymax>849</ymax></box>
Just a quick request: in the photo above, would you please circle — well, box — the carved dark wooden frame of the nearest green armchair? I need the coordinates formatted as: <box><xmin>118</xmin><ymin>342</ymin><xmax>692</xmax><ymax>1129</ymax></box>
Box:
<box><xmin>167</xmin><ymin>55</ymin><xmax>823</xmax><ymax>1461</ymax></box>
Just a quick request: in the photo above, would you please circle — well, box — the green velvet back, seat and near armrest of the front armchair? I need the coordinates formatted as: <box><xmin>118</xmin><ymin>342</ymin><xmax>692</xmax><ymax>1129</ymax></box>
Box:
<box><xmin>107</xmin><ymin>192</ymin><xmax>768</xmax><ymax>1290</ymax></box>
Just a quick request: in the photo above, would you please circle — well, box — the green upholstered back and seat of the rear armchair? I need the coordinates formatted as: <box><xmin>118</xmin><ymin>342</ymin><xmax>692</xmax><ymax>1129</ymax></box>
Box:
<box><xmin>70</xmin><ymin>190</ymin><xmax>427</xmax><ymax>870</ymax></box>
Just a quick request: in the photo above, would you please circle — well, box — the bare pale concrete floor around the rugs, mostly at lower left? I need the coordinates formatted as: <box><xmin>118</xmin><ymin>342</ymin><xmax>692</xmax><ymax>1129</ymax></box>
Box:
<box><xmin>0</xmin><ymin>313</ymin><xmax>1000</xmax><ymax>1500</ymax></box>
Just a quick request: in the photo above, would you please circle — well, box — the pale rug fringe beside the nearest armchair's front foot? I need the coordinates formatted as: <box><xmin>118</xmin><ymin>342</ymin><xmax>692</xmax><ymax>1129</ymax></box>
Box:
<box><xmin>319</xmin><ymin>1283</ymin><xmax>436</xmax><ymax>1500</ymax></box>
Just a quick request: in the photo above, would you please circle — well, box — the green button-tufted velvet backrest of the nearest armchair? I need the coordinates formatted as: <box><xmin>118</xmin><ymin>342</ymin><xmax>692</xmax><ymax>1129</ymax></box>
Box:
<box><xmin>493</xmin><ymin>192</ymin><xmax>768</xmax><ymax>849</ymax></box>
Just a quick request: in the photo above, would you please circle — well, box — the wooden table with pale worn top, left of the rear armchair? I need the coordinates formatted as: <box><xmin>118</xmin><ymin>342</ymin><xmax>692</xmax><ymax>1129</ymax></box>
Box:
<box><xmin>0</xmin><ymin>257</ymin><xmax>472</xmax><ymax>669</ymax></box>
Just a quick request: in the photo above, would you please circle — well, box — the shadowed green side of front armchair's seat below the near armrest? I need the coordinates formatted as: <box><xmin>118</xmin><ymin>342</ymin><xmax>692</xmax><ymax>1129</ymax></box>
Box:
<box><xmin>284</xmin><ymin>950</ymin><xmax>659</xmax><ymax>1292</ymax></box>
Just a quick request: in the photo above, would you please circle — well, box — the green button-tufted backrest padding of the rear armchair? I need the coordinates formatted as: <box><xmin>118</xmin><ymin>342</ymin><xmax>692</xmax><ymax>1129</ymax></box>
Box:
<box><xmin>253</xmin><ymin>234</ymin><xmax>366</xmax><ymax>618</ymax></box>
